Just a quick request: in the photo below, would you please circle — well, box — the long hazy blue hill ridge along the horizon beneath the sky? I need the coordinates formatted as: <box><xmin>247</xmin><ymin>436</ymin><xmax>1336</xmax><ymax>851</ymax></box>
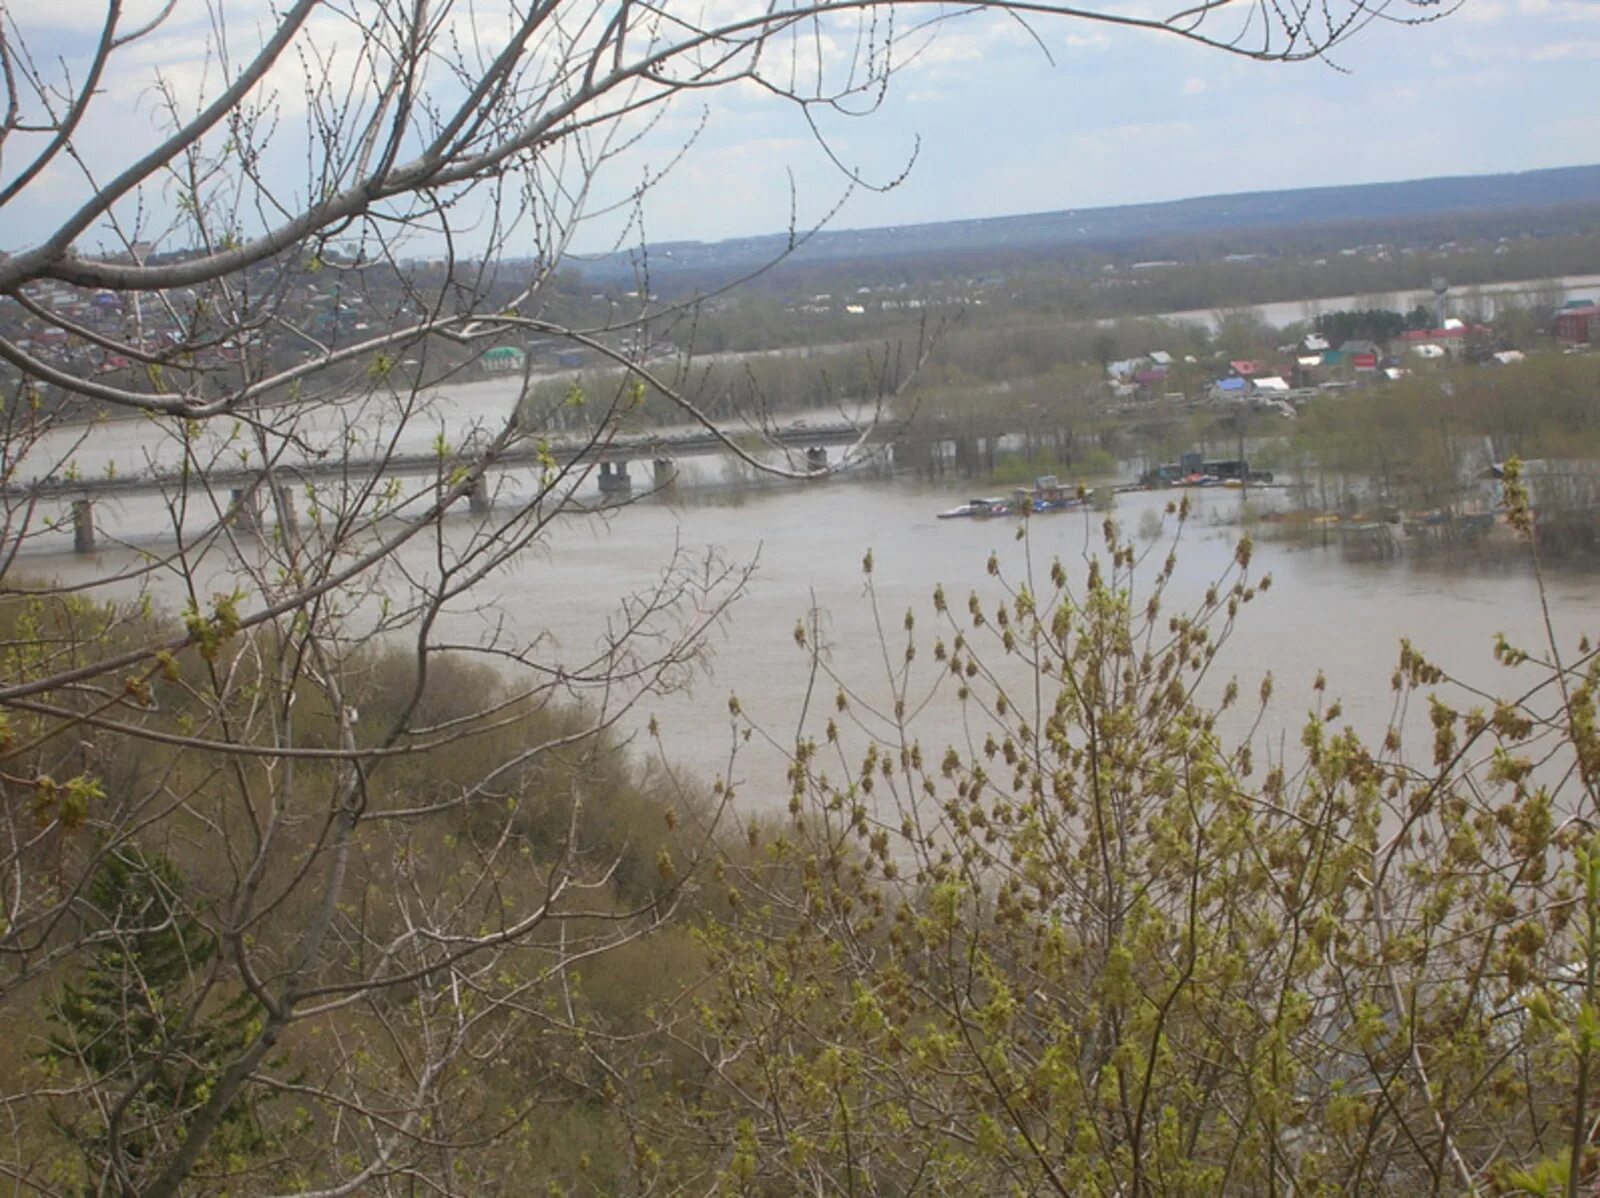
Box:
<box><xmin>579</xmin><ymin>166</ymin><xmax>1600</xmax><ymax>283</ymax></box>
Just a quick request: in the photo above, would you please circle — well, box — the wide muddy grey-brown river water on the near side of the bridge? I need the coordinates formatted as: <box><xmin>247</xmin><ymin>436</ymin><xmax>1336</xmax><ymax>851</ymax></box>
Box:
<box><xmin>22</xmin><ymin>467</ymin><xmax>1600</xmax><ymax>811</ymax></box>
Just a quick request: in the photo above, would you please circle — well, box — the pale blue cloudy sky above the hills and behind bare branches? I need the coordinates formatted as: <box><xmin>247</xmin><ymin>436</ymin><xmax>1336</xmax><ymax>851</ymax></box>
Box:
<box><xmin>0</xmin><ymin>0</ymin><xmax>1600</xmax><ymax>250</ymax></box>
